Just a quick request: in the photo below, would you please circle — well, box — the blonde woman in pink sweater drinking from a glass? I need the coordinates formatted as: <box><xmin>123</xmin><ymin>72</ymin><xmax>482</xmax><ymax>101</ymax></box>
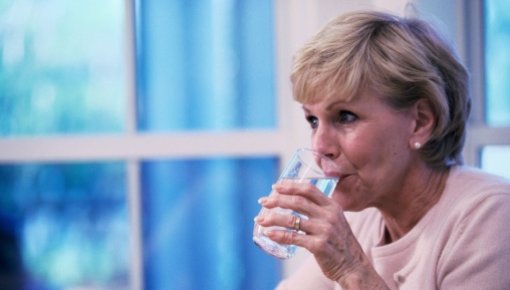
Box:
<box><xmin>257</xmin><ymin>12</ymin><xmax>510</xmax><ymax>290</ymax></box>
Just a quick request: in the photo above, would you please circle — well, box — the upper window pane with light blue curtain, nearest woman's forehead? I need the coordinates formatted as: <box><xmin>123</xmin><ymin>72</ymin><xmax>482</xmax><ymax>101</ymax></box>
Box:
<box><xmin>136</xmin><ymin>0</ymin><xmax>276</xmax><ymax>131</ymax></box>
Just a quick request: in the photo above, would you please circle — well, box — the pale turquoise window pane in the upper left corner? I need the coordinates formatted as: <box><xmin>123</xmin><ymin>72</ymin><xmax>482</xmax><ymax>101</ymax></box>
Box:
<box><xmin>0</xmin><ymin>0</ymin><xmax>126</xmax><ymax>136</ymax></box>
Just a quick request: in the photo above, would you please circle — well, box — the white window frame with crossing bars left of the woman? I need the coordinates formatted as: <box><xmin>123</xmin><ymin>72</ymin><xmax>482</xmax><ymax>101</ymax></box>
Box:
<box><xmin>0</xmin><ymin>0</ymin><xmax>318</xmax><ymax>289</ymax></box>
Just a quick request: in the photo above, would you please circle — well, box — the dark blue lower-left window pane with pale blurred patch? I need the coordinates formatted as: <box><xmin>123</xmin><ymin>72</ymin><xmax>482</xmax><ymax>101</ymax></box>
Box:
<box><xmin>0</xmin><ymin>163</ymin><xmax>130</xmax><ymax>290</ymax></box>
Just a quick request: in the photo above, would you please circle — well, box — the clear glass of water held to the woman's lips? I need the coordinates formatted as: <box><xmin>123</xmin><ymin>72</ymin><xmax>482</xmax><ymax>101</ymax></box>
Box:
<box><xmin>253</xmin><ymin>148</ymin><xmax>339</xmax><ymax>259</ymax></box>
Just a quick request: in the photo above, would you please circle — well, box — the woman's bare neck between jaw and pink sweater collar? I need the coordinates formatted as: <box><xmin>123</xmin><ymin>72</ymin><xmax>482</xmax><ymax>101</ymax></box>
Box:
<box><xmin>379</xmin><ymin>164</ymin><xmax>449</xmax><ymax>244</ymax></box>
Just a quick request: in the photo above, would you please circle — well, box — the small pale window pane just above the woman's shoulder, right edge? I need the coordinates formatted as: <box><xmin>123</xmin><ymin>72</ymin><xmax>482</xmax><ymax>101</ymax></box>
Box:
<box><xmin>482</xmin><ymin>145</ymin><xmax>510</xmax><ymax>178</ymax></box>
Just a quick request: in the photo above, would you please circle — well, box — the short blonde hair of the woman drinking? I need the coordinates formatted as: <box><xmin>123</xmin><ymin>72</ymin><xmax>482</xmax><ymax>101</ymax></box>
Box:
<box><xmin>291</xmin><ymin>11</ymin><xmax>470</xmax><ymax>168</ymax></box>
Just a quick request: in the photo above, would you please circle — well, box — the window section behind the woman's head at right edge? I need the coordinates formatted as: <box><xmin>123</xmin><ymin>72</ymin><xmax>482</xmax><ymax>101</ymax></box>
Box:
<box><xmin>464</xmin><ymin>0</ymin><xmax>510</xmax><ymax>177</ymax></box>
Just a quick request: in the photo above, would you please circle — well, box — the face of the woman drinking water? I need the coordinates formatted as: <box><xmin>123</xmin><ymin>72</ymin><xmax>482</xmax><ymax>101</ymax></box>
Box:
<box><xmin>303</xmin><ymin>91</ymin><xmax>416</xmax><ymax>211</ymax></box>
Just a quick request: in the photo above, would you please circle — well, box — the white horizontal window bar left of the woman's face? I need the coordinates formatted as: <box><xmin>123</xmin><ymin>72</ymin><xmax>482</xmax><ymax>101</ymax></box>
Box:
<box><xmin>0</xmin><ymin>130</ymin><xmax>289</xmax><ymax>163</ymax></box>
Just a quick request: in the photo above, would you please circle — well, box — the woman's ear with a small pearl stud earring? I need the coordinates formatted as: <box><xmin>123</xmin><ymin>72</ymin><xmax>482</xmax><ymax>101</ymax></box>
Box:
<box><xmin>409</xmin><ymin>99</ymin><xmax>436</xmax><ymax>149</ymax></box>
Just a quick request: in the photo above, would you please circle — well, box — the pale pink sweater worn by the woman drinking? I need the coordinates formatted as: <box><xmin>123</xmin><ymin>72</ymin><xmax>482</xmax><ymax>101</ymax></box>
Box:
<box><xmin>277</xmin><ymin>167</ymin><xmax>510</xmax><ymax>290</ymax></box>
